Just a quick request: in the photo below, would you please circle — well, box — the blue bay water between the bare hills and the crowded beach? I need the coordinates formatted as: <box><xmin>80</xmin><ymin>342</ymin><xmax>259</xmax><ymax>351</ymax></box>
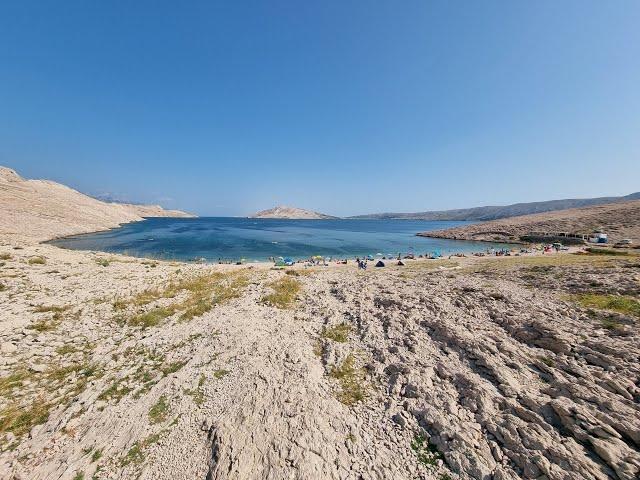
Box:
<box><xmin>51</xmin><ymin>217</ymin><xmax>516</xmax><ymax>262</ymax></box>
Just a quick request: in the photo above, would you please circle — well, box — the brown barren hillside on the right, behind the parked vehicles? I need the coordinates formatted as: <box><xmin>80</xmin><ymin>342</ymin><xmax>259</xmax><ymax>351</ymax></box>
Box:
<box><xmin>418</xmin><ymin>200</ymin><xmax>640</xmax><ymax>244</ymax></box>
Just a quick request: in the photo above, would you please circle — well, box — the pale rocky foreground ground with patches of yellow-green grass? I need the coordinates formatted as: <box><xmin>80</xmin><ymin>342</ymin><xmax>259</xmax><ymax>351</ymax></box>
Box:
<box><xmin>0</xmin><ymin>244</ymin><xmax>640</xmax><ymax>480</ymax></box>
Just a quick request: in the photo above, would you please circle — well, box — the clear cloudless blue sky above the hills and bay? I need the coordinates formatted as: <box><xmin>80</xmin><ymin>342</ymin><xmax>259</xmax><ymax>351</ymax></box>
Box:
<box><xmin>0</xmin><ymin>0</ymin><xmax>640</xmax><ymax>215</ymax></box>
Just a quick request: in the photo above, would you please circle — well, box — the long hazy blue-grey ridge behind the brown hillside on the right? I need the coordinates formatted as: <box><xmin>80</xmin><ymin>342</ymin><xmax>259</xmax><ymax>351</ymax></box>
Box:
<box><xmin>348</xmin><ymin>192</ymin><xmax>640</xmax><ymax>221</ymax></box>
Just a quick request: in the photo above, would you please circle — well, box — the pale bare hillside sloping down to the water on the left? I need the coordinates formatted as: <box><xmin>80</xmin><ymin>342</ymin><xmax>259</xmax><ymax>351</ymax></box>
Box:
<box><xmin>0</xmin><ymin>166</ymin><xmax>191</xmax><ymax>241</ymax></box>
